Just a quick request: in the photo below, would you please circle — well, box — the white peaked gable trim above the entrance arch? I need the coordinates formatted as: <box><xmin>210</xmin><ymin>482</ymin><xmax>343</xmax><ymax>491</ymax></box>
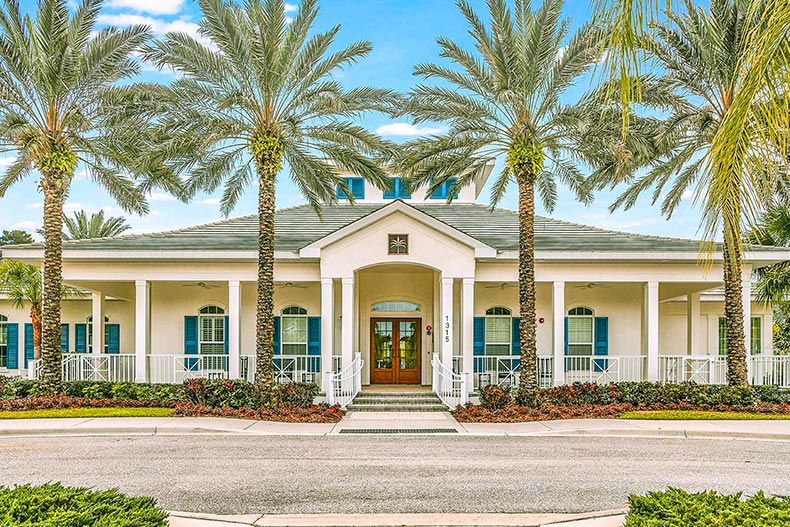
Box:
<box><xmin>299</xmin><ymin>201</ymin><xmax>497</xmax><ymax>258</ymax></box>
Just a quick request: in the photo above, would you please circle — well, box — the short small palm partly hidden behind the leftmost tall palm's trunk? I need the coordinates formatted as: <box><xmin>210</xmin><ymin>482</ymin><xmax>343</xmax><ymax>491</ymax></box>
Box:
<box><xmin>0</xmin><ymin>260</ymin><xmax>82</xmax><ymax>360</ymax></box>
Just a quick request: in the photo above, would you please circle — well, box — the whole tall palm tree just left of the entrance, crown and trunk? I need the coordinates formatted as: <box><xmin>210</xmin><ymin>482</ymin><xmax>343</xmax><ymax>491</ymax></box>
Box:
<box><xmin>143</xmin><ymin>0</ymin><xmax>394</xmax><ymax>388</ymax></box>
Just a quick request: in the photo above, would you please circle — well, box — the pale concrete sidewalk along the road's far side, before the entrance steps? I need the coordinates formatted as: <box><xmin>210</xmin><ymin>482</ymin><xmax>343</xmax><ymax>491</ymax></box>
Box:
<box><xmin>0</xmin><ymin>412</ymin><xmax>790</xmax><ymax>441</ymax></box>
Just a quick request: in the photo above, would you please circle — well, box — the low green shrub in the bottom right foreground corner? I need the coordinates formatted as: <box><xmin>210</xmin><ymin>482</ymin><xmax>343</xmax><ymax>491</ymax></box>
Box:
<box><xmin>624</xmin><ymin>488</ymin><xmax>790</xmax><ymax>527</ymax></box>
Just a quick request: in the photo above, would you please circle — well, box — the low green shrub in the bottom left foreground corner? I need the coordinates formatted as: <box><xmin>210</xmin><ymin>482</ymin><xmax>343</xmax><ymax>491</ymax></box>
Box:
<box><xmin>0</xmin><ymin>483</ymin><xmax>168</xmax><ymax>527</ymax></box>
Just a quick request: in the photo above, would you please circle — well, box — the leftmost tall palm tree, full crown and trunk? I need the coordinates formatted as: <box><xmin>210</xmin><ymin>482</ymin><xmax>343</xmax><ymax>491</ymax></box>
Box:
<box><xmin>0</xmin><ymin>0</ymin><xmax>175</xmax><ymax>386</ymax></box>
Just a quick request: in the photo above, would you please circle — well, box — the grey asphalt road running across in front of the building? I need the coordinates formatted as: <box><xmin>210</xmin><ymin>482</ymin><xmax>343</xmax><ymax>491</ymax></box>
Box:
<box><xmin>0</xmin><ymin>435</ymin><xmax>790</xmax><ymax>514</ymax></box>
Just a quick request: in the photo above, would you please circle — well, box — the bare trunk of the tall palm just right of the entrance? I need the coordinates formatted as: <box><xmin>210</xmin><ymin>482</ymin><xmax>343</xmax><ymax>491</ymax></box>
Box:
<box><xmin>514</xmin><ymin>165</ymin><xmax>538</xmax><ymax>400</ymax></box>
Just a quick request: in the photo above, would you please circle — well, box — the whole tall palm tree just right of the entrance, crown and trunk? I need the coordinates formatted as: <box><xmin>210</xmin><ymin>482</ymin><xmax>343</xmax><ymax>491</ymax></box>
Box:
<box><xmin>399</xmin><ymin>0</ymin><xmax>615</xmax><ymax>397</ymax></box>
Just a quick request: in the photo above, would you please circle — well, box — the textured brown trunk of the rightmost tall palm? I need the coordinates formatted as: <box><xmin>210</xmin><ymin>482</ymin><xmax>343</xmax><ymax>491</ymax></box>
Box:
<box><xmin>724</xmin><ymin>220</ymin><xmax>749</xmax><ymax>386</ymax></box>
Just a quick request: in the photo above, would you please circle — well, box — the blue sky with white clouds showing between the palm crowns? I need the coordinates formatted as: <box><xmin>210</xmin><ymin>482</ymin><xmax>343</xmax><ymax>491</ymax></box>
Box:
<box><xmin>0</xmin><ymin>0</ymin><xmax>698</xmax><ymax>238</ymax></box>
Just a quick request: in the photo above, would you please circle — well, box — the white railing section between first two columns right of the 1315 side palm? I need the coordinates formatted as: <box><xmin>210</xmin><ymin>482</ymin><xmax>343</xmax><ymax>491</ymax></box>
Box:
<box><xmin>565</xmin><ymin>355</ymin><xmax>647</xmax><ymax>384</ymax></box>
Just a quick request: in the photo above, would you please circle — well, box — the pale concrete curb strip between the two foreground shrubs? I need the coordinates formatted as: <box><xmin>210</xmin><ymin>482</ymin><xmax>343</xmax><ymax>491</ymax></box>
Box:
<box><xmin>170</xmin><ymin>510</ymin><xmax>625</xmax><ymax>527</ymax></box>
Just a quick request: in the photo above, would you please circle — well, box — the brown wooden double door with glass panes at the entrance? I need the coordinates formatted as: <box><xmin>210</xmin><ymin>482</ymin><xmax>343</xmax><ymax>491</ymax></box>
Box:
<box><xmin>370</xmin><ymin>318</ymin><xmax>422</xmax><ymax>384</ymax></box>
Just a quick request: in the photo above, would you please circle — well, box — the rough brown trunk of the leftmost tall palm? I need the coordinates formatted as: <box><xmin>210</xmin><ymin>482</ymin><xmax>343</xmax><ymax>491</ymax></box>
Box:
<box><xmin>41</xmin><ymin>170</ymin><xmax>66</xmax><ymax>389</ymax></box>
